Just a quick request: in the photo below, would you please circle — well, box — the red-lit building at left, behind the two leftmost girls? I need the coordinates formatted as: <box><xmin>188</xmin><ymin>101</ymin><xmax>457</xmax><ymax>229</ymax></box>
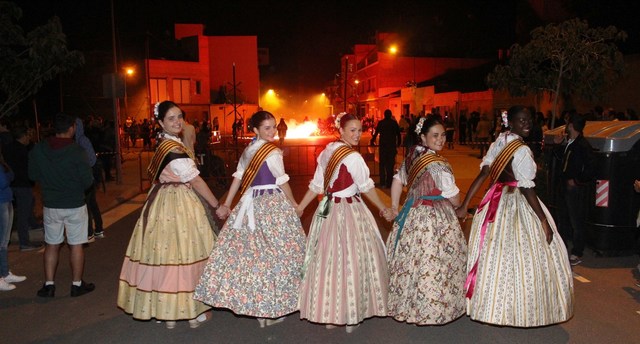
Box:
<box><xmin>145</xmin><ymin>24</ymin><xmax>260</xmax><ymax>132</ymax></box>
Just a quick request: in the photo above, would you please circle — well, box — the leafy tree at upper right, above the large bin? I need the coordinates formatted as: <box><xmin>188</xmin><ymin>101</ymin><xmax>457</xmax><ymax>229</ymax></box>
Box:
<box><xmin>487</xmin><ymin>19</ymin><xmax>627</xmax><ymax>128</ymax></box>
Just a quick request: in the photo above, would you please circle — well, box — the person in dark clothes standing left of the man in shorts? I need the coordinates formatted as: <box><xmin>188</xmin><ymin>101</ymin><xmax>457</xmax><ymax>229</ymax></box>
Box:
<box><xmin>2</xmin><ymin>126</ymin><xmax>42</xmax><ymax>251</ymax></box>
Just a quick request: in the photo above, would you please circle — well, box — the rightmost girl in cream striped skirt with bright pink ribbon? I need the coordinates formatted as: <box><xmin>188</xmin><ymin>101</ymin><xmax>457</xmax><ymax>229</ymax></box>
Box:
<box><xmin>456</xmin><ymin>106</ymin><xmax>573</xmax><ymax>327</ymax></box>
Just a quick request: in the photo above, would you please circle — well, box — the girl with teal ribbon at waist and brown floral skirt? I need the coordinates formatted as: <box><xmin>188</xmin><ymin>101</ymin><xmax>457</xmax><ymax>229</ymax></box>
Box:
<box><xmin>387</xmin><ymin>116</ymin><xmax>467</xmax><ymax>325</ymax></box>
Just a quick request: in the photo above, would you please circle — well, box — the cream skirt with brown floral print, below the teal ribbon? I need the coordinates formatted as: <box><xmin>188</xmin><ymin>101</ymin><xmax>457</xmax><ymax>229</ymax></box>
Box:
<box><xmin>387</xmin><ymin>200</ymin><xmax>467</xmax><ymax>325</ymax></box>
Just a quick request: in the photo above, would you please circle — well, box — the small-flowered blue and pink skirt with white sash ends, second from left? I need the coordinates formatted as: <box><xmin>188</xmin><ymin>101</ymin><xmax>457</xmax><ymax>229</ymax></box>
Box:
<box><xmin>194</xmin><ymin>190</ymin><xmax>305</xmax><ymax>318</ymax></box>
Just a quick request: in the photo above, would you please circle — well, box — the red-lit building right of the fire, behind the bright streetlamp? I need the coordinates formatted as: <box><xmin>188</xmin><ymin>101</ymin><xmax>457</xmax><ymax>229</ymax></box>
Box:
<box><xmin>328</xmin><ymin>33</ymin><xmax>488</xmax><ymax>118</ymax></box>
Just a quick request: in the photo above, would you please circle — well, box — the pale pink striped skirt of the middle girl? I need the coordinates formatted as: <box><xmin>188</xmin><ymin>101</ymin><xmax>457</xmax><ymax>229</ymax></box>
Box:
<box><xmin>299</xmin><ymin>199</ymin><xmax>389</xmax><ymax>325</ymax></box>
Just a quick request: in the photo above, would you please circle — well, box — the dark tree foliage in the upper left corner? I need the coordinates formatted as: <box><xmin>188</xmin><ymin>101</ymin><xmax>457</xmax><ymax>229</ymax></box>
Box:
<box><xmin>0</xmin><ymin>1</ymin><xmax>84</xmax><ymax>118</ymax></box>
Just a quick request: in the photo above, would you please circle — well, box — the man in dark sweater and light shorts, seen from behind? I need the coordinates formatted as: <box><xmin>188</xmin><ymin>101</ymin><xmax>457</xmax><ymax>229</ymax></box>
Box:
<box><xmin>29</xmin><ymin>113</ymin><xmax>95</xmax><ymax>297</ymax></box>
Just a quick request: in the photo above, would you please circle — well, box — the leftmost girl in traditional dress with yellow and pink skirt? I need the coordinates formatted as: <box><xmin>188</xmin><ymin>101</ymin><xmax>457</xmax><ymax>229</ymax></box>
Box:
<box><xmin>118</xmin><ymin>101</ymin><xmax>218</xmax><ymax>329</ymax></box>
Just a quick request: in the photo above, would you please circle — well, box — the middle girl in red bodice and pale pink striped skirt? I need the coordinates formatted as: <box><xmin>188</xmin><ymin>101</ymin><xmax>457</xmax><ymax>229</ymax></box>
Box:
<box><xmin>298</xmin><ymin>114</ymin><xmax>391</xmax><ymax>333</ymax></box>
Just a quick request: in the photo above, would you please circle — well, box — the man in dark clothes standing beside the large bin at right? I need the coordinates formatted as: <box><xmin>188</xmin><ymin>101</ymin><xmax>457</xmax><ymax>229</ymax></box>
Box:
<box><xmin>557</xmin><ymin>113</ymin><xmax>594</xmax><ymax>265</ymax></box>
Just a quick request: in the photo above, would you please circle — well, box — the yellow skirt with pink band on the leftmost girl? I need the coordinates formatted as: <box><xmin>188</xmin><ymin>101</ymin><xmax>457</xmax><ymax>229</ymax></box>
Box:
<box><xmin>118</xmin><ymin>184</ymin><xmax>216</xmax><ymax>320</ymax></box>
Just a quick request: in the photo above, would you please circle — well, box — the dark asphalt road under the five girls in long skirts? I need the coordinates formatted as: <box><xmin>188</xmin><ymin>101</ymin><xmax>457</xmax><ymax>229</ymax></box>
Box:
<box><xmin>0</xmin><ymin>138</ymin><xmax>640</xmax><ymax>344</ymax></box>
